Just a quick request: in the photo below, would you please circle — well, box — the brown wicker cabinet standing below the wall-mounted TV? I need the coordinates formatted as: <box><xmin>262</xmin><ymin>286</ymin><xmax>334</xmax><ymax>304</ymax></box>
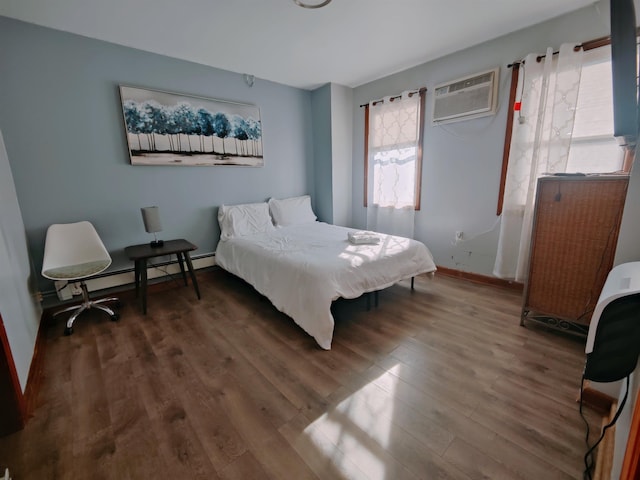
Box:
<box><xmin>521</xmin><ymin>175</ymin><xmax>628</xmax><ymax>334</ymax></box>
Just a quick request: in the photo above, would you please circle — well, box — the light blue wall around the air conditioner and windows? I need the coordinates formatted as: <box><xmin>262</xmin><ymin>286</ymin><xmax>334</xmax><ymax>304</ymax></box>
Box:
<box><xmin>353</xmin><ymin>1</ymin><xmax>609</xmax><ymax>275</ymax></box>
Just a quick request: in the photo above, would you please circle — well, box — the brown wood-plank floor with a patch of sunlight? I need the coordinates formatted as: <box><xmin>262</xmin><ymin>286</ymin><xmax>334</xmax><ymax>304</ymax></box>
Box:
<box><xmin>0</xmin><ymin>269</ymin><xmax>599</xmax><ymax>480</ymax></box>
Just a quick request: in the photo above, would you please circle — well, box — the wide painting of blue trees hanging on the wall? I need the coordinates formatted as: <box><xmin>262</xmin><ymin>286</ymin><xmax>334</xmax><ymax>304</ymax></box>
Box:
<box><xmin>119</xmin><ymin>85</ymin><xmax>264</xmax><ymax>167</ymax></box>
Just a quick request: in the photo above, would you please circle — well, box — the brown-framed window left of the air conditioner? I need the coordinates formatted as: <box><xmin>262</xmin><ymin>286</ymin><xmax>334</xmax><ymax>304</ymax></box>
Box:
<box><xmin>364</xmin><ymin>88</ymin><xmax>426</xmax><ymax>210</ymax></box>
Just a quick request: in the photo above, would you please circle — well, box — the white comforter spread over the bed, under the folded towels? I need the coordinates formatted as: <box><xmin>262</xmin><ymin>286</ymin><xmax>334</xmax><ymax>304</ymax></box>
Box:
<box><xmin>216</xmin><ymin>222</ymin><xmax>436</xmax><ymax>350</ymax></box>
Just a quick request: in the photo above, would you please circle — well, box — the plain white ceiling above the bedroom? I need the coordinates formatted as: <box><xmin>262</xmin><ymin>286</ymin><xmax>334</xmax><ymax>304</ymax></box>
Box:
<box><xmin>0</xmin><ymin>0</ymin><xmax>594</xmax><ymax>89</ymax></box>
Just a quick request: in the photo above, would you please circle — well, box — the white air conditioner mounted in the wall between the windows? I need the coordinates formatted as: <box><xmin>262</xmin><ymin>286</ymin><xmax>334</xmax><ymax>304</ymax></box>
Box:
<box><xmin>431</xmin><ymin>68</ymin><xmax>500</xmax><ymax>125</ymax></box>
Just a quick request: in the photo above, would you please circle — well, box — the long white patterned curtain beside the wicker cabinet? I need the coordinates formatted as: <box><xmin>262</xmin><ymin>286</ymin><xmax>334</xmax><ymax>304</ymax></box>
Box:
<box><xmin>493</xmin><ymin>44</ymin><xmax>583</xmax><ymax>282</ymax></box>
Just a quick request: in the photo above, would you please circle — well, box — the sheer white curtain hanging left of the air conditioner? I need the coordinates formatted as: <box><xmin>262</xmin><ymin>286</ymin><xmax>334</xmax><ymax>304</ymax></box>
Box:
<box><xmin>367</xmin><ymin>92</ymin><xmax>420</xmax><ymax>238</ymax></box>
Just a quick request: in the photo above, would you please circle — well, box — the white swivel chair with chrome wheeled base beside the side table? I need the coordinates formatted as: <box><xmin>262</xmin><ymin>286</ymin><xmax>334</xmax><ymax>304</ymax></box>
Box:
<box><xmin>42</xmin><ymin>221</ymin><xmax>120</xmax><ymax>335</ymax></box>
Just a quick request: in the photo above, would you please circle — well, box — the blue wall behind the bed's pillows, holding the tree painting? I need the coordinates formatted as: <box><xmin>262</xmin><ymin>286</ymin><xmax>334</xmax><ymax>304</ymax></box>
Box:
<box><xmin>0</xmin><ymin>17</ymin><xmax>314</xmax><ymax>290</ymax></box>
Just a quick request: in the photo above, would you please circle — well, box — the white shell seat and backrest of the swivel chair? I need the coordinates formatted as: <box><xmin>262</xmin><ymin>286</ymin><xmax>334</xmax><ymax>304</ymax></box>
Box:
<box><xmin>42</xmin><ymin>221</ymin><xmax>111</xmax><ymax>280</ymax></box>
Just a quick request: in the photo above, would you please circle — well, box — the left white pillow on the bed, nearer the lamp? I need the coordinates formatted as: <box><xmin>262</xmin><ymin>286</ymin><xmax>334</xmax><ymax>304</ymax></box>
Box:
<box><xmin>218</xmin><ymin>202</ymin><xmax>275</xmax><ymax>240</ymax></box>
